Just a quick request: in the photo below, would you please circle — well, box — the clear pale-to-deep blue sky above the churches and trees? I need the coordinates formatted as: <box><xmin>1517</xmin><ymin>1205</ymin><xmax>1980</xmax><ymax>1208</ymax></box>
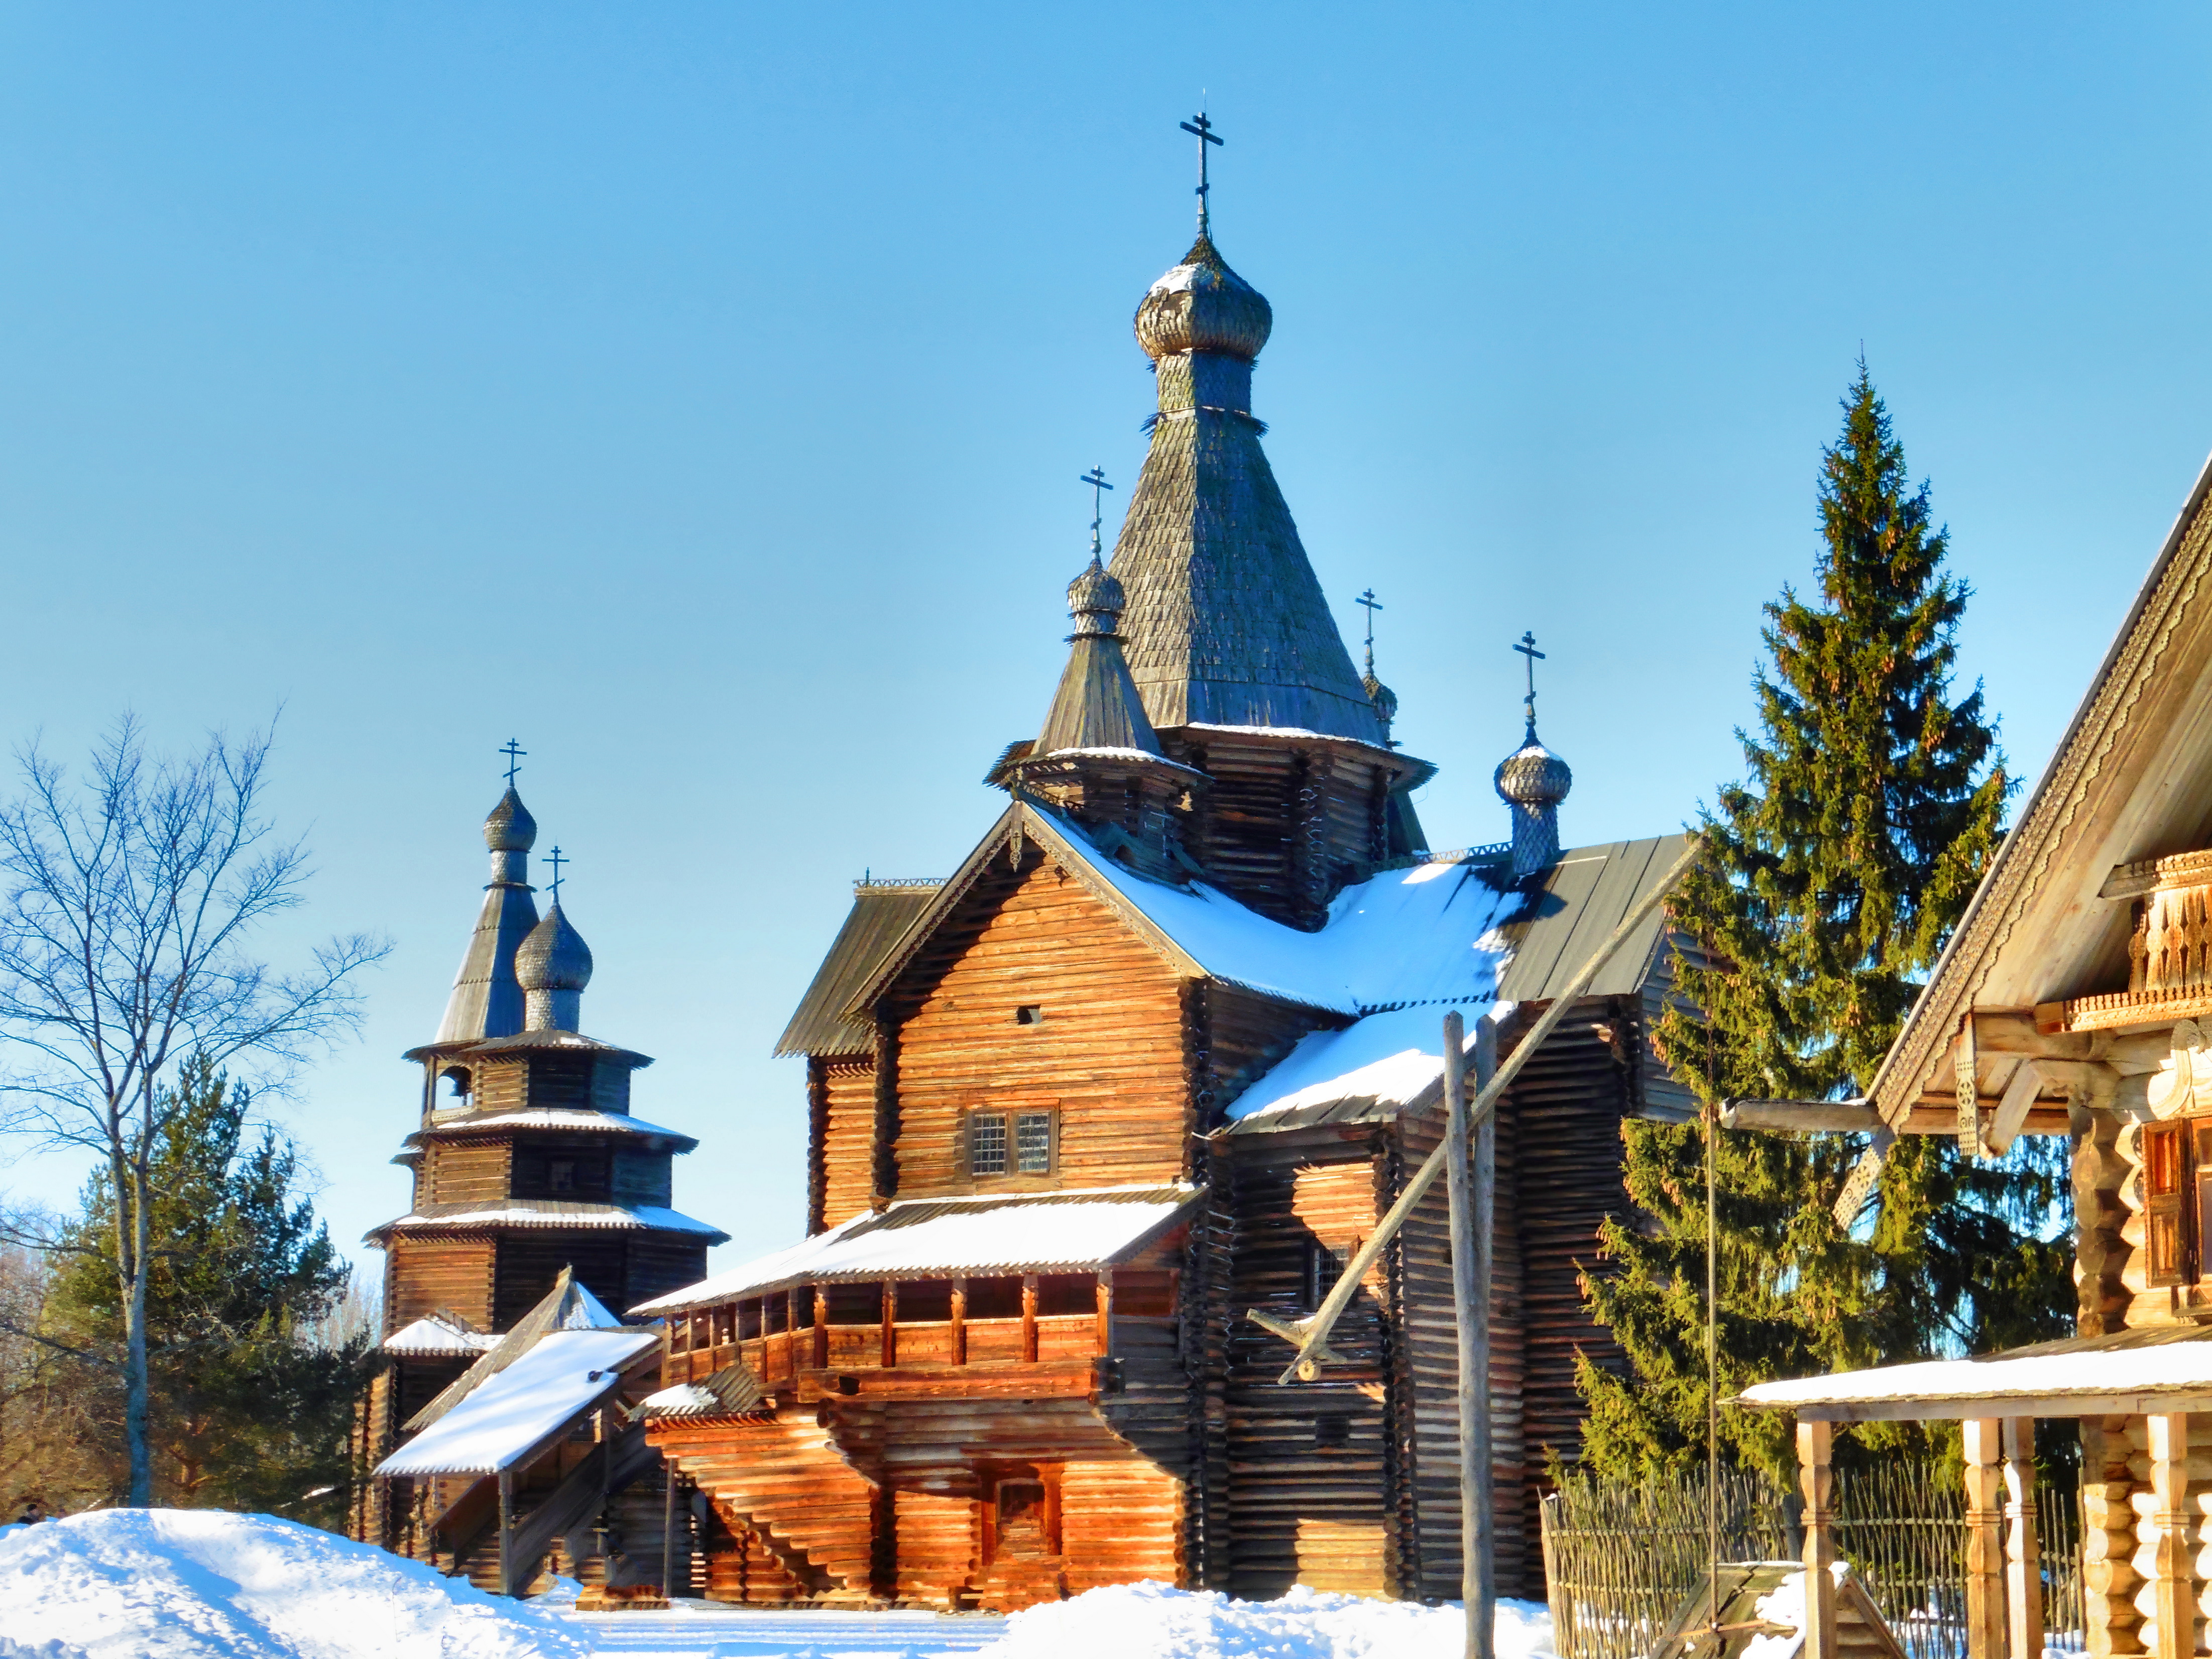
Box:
<box><xmin>0</xmin><ymin>0</ymin><xmax>2212</xmax><ymax>1263</ymax></box>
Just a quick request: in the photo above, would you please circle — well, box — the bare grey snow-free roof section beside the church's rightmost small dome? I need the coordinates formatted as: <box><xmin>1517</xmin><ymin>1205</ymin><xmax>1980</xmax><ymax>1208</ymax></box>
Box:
<box><xmin>1497</xmin><ymin>836</ymin><xmax>1688</xmax><ymax>1002</ymax></box>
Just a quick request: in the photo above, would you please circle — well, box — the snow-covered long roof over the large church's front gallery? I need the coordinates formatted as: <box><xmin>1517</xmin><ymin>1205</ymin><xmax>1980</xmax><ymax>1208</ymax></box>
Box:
<box><xmin>630</xmin><ymin>1186</ymin><xmax>1203</xmax><ymax>1318</ymax></box>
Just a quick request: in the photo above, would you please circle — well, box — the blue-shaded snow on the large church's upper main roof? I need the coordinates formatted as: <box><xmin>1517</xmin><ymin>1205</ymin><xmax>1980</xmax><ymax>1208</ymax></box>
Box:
<box><xmin>1048</xmin><ymin>803</ymin><xmax>1522</xmax><ymax>1015</ymax></box>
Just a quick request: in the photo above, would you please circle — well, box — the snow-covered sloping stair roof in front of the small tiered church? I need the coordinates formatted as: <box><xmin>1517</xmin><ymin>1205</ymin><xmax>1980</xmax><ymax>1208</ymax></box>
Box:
<box><xmin>376</xmin><ymin>1330</ymin><xmax>661</xmax><ymax>1475</ymax></box>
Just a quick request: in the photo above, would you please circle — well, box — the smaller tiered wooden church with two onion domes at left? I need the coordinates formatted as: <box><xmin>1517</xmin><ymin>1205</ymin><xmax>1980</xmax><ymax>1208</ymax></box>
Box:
<box><xmin>352</xmin><ymin>788</ymin><xmax>728</xmax><ymax>1555</ymax></box>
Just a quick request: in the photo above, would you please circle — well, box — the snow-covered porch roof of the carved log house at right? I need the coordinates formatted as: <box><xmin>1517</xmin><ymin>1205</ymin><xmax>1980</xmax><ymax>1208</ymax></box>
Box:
<box><xmin>1741</xmin><ymin>1325</ymin><xmax>2212</xmax><ymax>1418</ymax></box>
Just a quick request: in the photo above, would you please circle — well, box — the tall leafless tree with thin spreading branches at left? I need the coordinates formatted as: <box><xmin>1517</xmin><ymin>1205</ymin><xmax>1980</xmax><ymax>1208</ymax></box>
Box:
<box><xmin>0</xmin><ymin>719</ymin><xmax>389</xmax><ymax>1506</ymax></box>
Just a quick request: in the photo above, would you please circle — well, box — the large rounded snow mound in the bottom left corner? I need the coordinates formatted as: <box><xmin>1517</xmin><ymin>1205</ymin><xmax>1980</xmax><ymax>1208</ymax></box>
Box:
<box><xmin>0</xmin><ymin>1509</ymin><xmax>589</xmax><ymax>1659</ymax></box>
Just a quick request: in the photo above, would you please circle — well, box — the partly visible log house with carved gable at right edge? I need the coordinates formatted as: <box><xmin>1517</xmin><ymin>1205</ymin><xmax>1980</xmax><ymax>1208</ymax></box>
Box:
<box><xmin>1738</xmin><ymin>449</ymin><xmax>2212</xmax><ymax>1659</ymax></box>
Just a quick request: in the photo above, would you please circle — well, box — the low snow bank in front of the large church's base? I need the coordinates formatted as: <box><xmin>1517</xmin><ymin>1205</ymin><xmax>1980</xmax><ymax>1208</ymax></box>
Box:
<box><xmin>976</xmin><ymin>1584</ymin><xmax>1551</xmax><ymax>1659</ymax></box>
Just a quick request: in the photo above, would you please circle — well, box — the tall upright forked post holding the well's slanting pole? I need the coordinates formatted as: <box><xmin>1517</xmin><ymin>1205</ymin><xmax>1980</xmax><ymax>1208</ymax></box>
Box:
<box><xmin>1444</xmin><ymin>1009</ymin><xmax>1497</xmax><ymax>1659</ymax></box>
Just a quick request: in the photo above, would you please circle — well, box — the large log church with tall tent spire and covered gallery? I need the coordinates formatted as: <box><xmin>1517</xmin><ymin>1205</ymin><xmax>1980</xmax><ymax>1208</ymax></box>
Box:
<box><xmin>632</xmin><ymin>197</ymin><xmax>1690</xmax><ymax>1608</ymax></box>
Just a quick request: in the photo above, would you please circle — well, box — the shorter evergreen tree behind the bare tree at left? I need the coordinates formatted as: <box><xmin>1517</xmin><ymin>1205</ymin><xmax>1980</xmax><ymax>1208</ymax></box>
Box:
<box><xmin>47</xmin><ymin>1057</ymin><xmax>361</xmax><ymax>1520</ymax></box>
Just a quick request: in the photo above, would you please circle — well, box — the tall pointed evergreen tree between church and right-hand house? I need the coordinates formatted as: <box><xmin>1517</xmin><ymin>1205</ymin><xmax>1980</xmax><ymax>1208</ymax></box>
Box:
<box><xmin>1582</xmin><ymin>361</ymin><xmax>2072</xmax><ymax>1475</ymax></box>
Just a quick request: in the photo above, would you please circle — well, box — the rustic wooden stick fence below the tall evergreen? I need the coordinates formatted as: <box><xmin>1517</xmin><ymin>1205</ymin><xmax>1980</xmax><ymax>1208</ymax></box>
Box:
<box><xmin>1544</xmin><ymin>1462</ymin><xmax>2081</xmax><ymax>1659</ymax></box>
